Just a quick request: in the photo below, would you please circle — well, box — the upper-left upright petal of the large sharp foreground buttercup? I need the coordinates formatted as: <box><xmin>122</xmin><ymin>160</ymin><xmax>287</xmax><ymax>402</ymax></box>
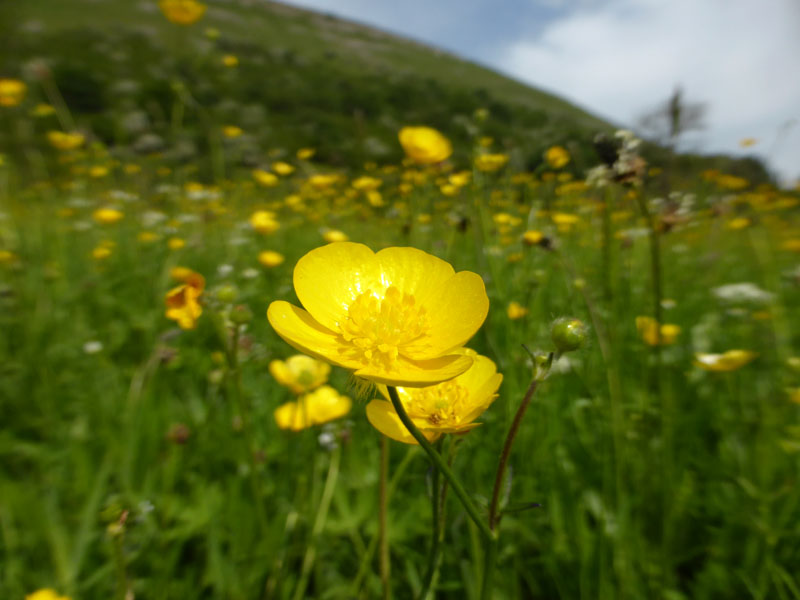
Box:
<box><xmin>294</xmin><ymin>242</ymin><xmax>377</xmax><ymax>330</ymax></box>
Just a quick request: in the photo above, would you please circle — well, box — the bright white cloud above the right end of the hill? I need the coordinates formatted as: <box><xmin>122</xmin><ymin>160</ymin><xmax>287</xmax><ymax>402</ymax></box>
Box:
<box><xmin>496</xmin><ymin>0</ymin><xmax>800</xmax><ymax>184</ymax></box>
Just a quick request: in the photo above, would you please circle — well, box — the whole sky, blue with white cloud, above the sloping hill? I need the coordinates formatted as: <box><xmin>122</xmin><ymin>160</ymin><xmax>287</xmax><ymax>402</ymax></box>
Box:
<box><xmin>283</xmin><ymin>0</ymin><xmax>800</xmax><ymax>184</ymax></box>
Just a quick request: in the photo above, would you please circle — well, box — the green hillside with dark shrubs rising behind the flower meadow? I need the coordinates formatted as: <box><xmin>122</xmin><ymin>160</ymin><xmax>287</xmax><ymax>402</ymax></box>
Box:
<box><xmin>0</xmin><ymin>0</ymin><xmax>766</xmax><ymax>180</ymax></box>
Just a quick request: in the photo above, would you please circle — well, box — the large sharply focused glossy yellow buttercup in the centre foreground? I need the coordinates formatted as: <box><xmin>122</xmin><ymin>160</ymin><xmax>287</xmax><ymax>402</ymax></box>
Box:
<box><xmin>267</xmin><ymin>242</ymin><xmax>489</xmax><ymax>387</ymax></box>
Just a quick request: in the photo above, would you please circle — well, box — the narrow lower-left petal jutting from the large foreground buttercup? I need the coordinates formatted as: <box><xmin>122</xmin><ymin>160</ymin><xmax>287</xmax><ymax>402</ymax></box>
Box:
<box><xmin>267</xmin><ymin>300</ymin><xmax>361</xmax><ymax>369</ymax></box>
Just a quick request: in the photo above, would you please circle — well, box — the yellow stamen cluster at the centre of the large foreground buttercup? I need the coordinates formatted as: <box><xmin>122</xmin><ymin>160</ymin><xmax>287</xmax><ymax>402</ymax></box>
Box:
<box><xmin>339</xmin><ymin>286</ymin><xmax>428</xmax><ymax>369</ymax></box>
